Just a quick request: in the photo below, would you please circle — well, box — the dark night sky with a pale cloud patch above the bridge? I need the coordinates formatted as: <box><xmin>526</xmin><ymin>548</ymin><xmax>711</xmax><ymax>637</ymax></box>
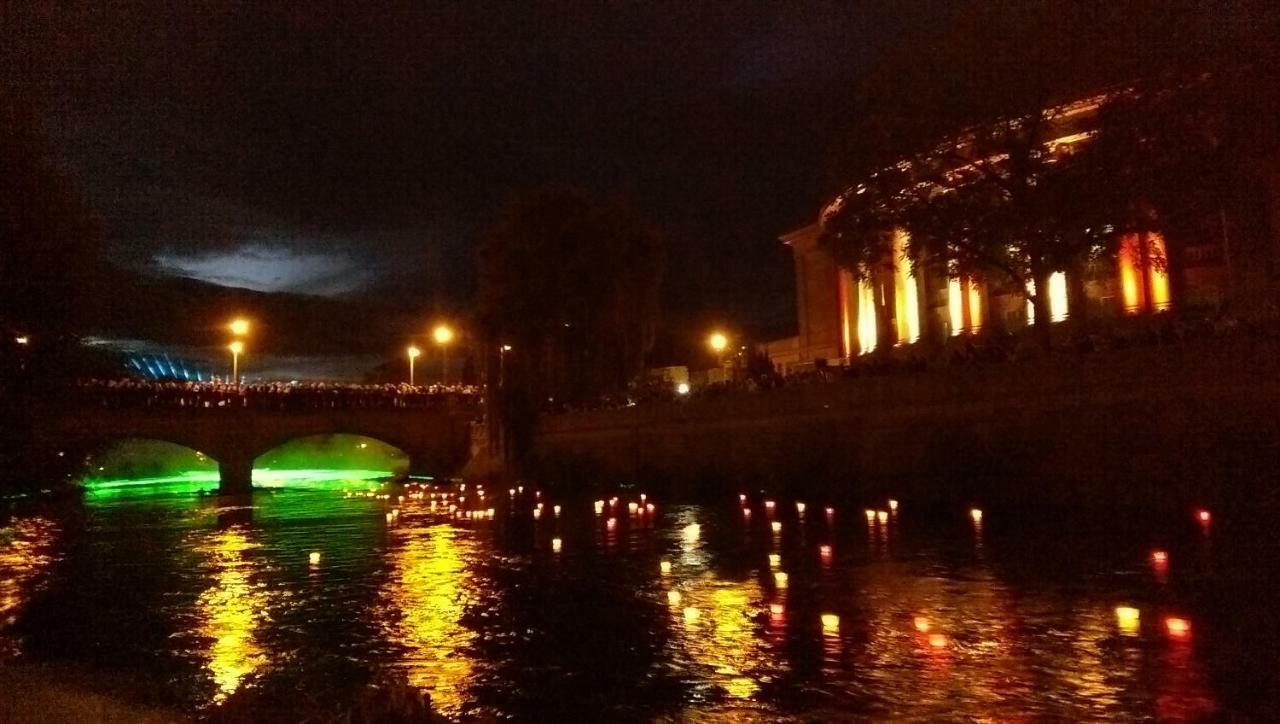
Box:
<box><xmin>5</xmin><ymin>1</ymin><xmax>952</xmax><ymax>333</ymax></box>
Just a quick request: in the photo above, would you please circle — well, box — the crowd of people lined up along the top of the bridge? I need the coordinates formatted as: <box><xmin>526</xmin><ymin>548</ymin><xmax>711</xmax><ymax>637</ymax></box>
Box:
<box><xmin>67</xmin><ymin>379</ymin><xmax>480</xmax><ymax>411</ymax></box>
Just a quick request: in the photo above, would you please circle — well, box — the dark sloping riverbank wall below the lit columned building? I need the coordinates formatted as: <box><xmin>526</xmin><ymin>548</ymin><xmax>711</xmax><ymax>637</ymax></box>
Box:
<box><xmin>532</xmin><ymin>336</ymin><xmax>1280</xmax><ymax>508</ymax></box>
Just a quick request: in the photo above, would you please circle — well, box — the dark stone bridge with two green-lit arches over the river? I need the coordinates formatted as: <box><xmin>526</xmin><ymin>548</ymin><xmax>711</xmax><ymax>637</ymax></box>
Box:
<box><xmin>43</xmin><ymin>404</ymin><xmax>475</xmax><ymax>494</ymax></box>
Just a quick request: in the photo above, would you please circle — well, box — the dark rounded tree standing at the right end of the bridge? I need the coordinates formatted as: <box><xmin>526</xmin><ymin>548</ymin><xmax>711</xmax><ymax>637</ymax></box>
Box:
<box><xmin>480</xmin><ymin>189</ymin><xmax>664</xmax><ymax>465</ymax></box>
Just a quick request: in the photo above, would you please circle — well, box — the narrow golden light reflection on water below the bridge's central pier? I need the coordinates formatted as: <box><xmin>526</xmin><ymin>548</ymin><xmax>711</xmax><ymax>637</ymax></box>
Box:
<box><xmin>195</xmin><ymin>526</ymin><xmax>269</xmax><ymax>702</ymax></box>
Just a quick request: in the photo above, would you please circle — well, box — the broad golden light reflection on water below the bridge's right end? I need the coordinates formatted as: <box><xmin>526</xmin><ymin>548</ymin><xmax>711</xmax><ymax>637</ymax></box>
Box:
<box><xmin>381</xmin><ymin>523</ymin><xmax>475</xmax><ymax>716</ymax></box>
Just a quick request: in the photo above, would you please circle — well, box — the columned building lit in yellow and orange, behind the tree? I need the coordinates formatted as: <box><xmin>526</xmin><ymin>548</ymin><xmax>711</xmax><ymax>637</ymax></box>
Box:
<box><xmin>759</xmin><ymin>95</ymin><xmax>1280</xmax><ymax>374</ymax></box>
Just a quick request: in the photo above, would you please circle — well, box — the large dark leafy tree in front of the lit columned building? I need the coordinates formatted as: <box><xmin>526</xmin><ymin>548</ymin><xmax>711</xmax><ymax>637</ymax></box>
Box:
<box><xmin>820</xmin><ymin>1</ymin><xmax>1239</xmax><ymax>347</ymax></box>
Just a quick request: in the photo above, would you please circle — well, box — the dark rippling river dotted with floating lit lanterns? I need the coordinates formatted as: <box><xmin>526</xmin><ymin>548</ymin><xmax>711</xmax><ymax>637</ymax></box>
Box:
<box><xmin>0</xmin><ymin>473</ymin><xmax>1280</xmax><ymax>721</ymax></box>
